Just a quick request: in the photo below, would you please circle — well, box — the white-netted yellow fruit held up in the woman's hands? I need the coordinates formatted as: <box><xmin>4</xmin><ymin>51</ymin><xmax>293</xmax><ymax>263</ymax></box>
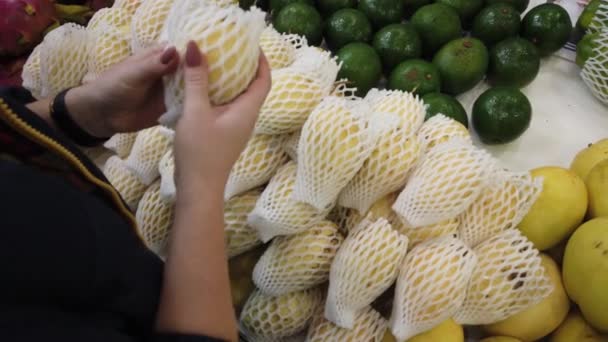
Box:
<box><xmin>159</xmin><ymin>0</ymin><xmax>266</xmax><ymax>126</ymax></box>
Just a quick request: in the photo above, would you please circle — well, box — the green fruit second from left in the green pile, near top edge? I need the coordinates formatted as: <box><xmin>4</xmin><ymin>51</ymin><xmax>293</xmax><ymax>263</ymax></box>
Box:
<box><xmin>325</xmin><ymin>8</ymin><xmax>372</xmax><ymax>50</ymax></box>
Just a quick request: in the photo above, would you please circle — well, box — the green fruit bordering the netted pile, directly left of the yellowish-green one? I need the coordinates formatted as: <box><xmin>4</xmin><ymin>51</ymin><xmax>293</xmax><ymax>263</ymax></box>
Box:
<box><xmin>388</xmin><ymin>59</ymin><xmax>441</xmax><ymax>96</ymax></box>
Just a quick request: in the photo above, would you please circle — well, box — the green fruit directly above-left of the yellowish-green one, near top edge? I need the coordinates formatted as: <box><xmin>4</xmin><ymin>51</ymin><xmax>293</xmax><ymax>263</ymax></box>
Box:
<box><xmin>411</xmin><ymin>4</ymin><xmax>462</xmax><ymax>56</ymax></box>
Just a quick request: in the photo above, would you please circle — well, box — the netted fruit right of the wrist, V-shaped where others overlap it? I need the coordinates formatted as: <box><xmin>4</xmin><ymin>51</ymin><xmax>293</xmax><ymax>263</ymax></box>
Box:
<box><xmin>248</xmin><ymin>161</ymin><xmax>333</xmax><ymax>242</ymax></box>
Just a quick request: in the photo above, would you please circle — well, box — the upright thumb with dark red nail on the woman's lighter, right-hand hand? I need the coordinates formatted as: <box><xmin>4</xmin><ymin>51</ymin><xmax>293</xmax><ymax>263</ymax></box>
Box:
<box><xmin>184</xmin><ymin>41</ymin><xmax>211</xmax><ymax>115</ymax></box>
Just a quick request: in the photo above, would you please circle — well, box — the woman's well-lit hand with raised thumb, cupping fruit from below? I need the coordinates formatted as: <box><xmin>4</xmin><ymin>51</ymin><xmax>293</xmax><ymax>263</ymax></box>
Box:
<box><xmin>175</xmin><ymin>42</ymin><xmax>271</xmax><ymax>196</ymax></box>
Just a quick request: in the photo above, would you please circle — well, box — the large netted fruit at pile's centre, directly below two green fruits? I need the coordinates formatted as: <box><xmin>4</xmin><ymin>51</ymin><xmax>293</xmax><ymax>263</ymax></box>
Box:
<box><xmin>294</xmin><ymin>96</ymin><xmax>374</xmax><ymax>210</ymax></box>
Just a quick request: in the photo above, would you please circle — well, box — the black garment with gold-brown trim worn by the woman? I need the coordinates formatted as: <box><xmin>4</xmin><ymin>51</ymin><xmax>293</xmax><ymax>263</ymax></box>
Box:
<box><xmin>0</xmin><ymin>89</ymin><xmax>219</xmax><ymax>342</ymax></box>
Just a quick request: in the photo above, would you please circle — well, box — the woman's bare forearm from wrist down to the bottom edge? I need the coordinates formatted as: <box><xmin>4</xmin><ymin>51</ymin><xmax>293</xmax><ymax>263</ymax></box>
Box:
<box><xmin>157</xmin><ymin>183</ymin><xmax>237</xmax><ymax>341</ymax></box>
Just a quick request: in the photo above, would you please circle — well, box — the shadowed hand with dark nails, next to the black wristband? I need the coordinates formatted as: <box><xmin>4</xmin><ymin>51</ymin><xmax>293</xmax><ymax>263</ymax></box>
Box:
<box><xmin>66</xmin><ymin>47</ymin><xmax>179</xmax><ymax>137</ymax></box>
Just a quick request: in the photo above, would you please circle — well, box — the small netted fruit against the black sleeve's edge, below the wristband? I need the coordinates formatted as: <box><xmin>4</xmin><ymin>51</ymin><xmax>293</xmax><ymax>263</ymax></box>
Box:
<box><xmin>103</xmin><ymin>156</ymin><xmax>147</xmax><ymax>212</ymax></box>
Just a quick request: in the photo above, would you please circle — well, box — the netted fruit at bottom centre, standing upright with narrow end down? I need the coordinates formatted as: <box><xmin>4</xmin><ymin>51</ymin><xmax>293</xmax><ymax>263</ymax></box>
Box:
<box><xmin>325</xmin><ymin>219</ymin><xmax>408</xmax><ymax>329</ymax></box>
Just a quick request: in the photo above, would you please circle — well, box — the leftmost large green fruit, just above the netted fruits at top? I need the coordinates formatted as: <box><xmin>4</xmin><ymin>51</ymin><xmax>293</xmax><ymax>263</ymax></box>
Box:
<box><xmin>272</xmin><ymin>2</ymin><xmax>323</xmax><ymax>45</ymax></box>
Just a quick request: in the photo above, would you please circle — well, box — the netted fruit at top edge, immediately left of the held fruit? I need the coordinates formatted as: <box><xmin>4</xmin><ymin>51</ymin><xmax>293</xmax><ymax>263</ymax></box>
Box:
<box><xmin>131</xmin><ymin>0</ymin><xmax>175</xmax><ymax>53</ymax></box>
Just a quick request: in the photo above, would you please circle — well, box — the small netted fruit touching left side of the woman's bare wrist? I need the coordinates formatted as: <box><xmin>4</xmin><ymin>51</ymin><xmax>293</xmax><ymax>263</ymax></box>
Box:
<box><xmin>127</xmin><ymin>126</ymin><xmax>172</xmax><ymax>185</ymax></box>
